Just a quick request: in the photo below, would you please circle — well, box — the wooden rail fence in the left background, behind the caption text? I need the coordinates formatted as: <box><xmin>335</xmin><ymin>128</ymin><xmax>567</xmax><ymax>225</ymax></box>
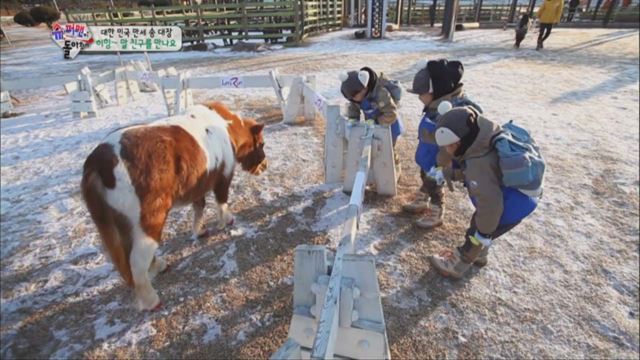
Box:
<box><xmin>64</xmin><ymin>0</ymin><xmax>343</xmax><ymax>45</ymax></box>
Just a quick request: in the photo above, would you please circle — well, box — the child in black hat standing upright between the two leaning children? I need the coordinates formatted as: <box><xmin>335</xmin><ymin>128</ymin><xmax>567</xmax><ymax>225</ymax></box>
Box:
<box><xmin>402</xmin><ymin>59</ymin><xmax>482</xmax><ymax>229</ymax></box>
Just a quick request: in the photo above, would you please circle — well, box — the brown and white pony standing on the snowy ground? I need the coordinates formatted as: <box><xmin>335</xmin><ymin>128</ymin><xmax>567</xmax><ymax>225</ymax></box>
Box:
<box><xmin>81</xmin><ymin>103</ymin><xmax>267</xmax><ymax>310</ymax></box>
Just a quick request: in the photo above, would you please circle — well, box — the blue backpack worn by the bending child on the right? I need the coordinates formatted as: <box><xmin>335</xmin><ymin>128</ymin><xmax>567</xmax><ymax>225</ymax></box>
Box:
<box><xmin>491</xmin><ymin>120</ymin><xmax>546</xmax><ymax>197</ymax></box>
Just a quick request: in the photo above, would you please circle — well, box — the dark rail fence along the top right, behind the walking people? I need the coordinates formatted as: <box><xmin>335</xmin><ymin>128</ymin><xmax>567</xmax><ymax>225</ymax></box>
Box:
<box><xmin>387</xmin><ymin>0</ymin><xmax>640</xmax><ymax>26</ymax></box>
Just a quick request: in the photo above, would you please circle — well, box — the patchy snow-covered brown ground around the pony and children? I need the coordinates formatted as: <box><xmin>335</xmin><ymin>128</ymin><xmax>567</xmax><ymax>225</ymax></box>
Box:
<box><xmin>0</xmin><ymin>23</ymin><xmax>640</xmax><ymax>358</ymax></box>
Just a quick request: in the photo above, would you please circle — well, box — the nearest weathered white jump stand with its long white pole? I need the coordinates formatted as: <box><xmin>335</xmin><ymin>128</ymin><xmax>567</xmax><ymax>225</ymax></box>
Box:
<box><xmin>272</xmin><ymin>124</ymin><xmax>390</xmax><ymax>359</ymax></box>
